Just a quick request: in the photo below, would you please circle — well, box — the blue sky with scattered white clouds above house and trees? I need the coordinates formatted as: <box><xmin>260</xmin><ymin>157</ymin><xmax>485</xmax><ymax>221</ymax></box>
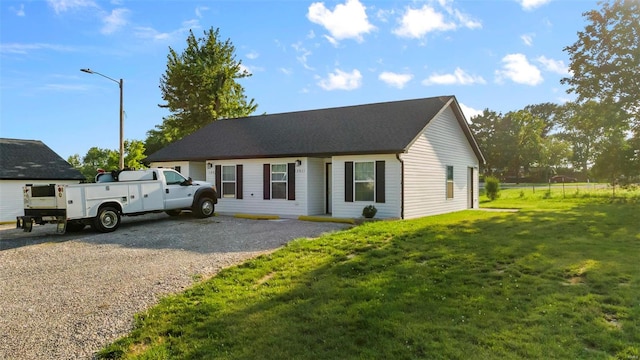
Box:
<box><xmin>0</xmin><ymin>0</ymin><xmax>599</xmax><ymax>160</ymax></box>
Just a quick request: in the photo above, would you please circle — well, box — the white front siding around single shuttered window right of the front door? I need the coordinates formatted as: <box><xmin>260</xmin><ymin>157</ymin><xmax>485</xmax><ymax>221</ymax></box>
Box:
<box><xmin>331</xmin><ymin>154</ymin><xmax>401</xmax><ymax>218</ymax></box>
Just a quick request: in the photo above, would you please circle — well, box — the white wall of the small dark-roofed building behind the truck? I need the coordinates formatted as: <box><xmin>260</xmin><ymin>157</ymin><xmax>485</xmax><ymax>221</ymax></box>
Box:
<box><xmin>0</xmin><ymin>179</ymin><xmax>79</xmax><ymax>223</ymax></box>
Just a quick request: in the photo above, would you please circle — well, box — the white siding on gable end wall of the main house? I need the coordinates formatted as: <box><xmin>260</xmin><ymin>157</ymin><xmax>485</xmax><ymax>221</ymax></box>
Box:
<box><xmin>401</xmin><ymin>107</ymin><xmax>478</xmax><ymax>219</ymax></box>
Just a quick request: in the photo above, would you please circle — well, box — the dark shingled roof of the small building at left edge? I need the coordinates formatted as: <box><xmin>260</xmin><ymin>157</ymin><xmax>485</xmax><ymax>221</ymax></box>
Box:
<box><xmin>0</xmin><ymin>138</ymin><xmax>84</xmax><ymax>180</ymax></box>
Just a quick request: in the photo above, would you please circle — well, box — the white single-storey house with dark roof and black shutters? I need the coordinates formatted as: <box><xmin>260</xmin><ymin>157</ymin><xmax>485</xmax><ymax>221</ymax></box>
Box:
<box><xmin>147</xmin><ymin>96</ymin><xmax>484</xmax><ymax>219</ymax></box>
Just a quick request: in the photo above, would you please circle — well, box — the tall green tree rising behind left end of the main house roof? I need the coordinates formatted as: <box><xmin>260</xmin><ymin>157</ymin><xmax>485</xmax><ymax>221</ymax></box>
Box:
<box><xmin>146</xmin><ymin>29</ymin><xmax>258</xmax><ymax>151</ymax></box>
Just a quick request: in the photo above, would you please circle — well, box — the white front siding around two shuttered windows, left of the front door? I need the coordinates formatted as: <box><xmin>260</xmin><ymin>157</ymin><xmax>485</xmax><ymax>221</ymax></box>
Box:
<box><xmin>206</xmin><ymin>158</ymin><xmax>309</xmax><ymax>217</ymax></box>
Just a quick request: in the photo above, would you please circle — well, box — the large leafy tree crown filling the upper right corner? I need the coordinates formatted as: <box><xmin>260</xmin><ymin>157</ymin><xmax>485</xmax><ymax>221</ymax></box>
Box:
<box><xmin>560</xmin><ymin>0</ymin><xmax>640</xmax><ymax>128</ymax></box>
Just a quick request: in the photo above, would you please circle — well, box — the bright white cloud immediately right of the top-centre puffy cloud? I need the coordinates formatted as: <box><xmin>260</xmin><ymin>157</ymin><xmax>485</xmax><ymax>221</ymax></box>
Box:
<box><xmin>393</xmin><ymin>5</ymin><xmax>456</xmax><ymax>39</ymax></box>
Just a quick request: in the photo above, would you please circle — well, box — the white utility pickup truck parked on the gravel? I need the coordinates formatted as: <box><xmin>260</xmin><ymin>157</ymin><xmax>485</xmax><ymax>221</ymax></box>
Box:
<box><xmin>16</xmin><ymin>168</ymin><xmax>218</xmax><ymax>233</ymax></box>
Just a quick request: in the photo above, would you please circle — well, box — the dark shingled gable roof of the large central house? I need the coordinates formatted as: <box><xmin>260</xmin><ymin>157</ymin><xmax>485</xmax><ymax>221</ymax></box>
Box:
<box><xmin>146</xmin><ymin>96</ymin><xmax>483</xmax><ymax>162</ymax></box>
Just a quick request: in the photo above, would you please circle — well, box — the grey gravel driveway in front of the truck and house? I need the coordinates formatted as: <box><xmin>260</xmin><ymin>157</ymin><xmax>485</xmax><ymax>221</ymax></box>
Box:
<box><xmin>0</xmin><ymin>214</ymin><xmax>347</xmax><ymax>360</ymax></box>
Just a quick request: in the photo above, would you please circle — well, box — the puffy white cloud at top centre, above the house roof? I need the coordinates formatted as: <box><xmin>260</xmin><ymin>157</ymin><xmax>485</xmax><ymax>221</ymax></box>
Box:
<box><xmin>307</xmin><ymin>0</ymin><xmax>375</xmax><ymax>44</ymax></box>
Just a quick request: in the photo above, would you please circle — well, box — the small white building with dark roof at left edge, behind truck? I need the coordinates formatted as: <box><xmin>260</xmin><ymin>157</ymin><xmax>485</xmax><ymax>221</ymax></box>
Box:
<box><xmin>0</xmin><ymin>138</ymin><xmax>84</xmax><ymax>223</ymax></box>
